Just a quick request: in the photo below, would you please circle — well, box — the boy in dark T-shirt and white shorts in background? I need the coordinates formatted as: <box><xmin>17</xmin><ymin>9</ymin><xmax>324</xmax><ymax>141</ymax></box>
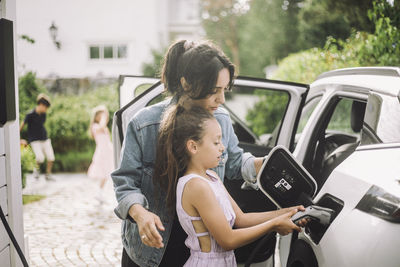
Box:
<box><xmin>19</xmin><ymin>94</ymin><xmax>54</xmax><ymax>181</ymax></box>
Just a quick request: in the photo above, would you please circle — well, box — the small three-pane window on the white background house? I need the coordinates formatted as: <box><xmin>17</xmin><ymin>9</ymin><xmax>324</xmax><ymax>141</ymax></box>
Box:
<box><xmin>89</xmin><ymin>44</ymin><xmax>128</xmax><ymax>60</ymax></box>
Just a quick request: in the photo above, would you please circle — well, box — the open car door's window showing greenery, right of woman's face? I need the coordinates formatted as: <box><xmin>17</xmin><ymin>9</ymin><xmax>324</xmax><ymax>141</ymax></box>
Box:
<box><xmin>225</xmin><ymin>86</ymin><xmax>289</xmax><ymax>147</ymax></box>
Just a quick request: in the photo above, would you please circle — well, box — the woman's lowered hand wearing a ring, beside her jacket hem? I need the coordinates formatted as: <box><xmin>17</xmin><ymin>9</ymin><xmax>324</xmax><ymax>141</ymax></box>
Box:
<box><xmin>129</xmin><ymin>204</ymin><xmax>165</xmax><ymax>248</ymax></box>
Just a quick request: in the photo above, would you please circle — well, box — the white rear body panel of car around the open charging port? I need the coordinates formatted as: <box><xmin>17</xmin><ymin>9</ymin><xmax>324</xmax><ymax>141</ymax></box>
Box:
<box><xmin>299</xmin><ymin>148</ymin><xmax>400</xmax><ymax>267</ymax></box>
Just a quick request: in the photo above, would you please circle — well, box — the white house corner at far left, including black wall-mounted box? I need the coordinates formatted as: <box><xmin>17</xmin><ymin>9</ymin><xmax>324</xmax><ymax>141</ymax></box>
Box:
<box><xmin>0</xmin><ymin>0</ymin><xmax>24</xmax><ymax>267</ymax></box>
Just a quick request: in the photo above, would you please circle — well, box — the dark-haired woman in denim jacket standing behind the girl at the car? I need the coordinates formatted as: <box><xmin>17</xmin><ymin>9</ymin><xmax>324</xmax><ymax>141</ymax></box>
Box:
<box><xmin>111</xmin><ymin>41</ymin><xmax>262</xmax><ymax>267</ymax></box>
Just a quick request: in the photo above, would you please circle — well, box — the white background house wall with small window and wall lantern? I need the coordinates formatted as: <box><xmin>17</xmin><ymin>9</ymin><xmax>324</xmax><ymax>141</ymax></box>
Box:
<box><xmin>17</xmin><ymin>0</ymin><xmax>166</xmax><ymax>77</ymax></box>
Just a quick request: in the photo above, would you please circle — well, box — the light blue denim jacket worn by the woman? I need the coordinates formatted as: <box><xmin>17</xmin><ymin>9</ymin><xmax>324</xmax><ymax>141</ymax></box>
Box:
<box><xmin>111</xmin><ymin>100</ymin><xmax>256</xmax><ymax>267</ymax></box>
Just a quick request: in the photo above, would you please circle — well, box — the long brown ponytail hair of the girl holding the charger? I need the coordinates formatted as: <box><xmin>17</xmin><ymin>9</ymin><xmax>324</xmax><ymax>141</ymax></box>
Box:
<box><xmin>153</xmin><ymin>104</ymin><xmax>215</xmax><ymax>213</ymax></box>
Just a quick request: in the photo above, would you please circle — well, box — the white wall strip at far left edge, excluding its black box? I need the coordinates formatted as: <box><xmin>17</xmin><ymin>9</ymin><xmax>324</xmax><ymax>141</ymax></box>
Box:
<box><xmin>0</xmin><ymin>0</ymin><xmax>24</xmax><ymax>267</ymax></box>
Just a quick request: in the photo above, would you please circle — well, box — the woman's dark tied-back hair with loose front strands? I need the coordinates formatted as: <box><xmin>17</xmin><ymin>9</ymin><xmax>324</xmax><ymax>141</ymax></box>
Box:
<box><xmin>161</xmin><ymin>40</ymin><xmax>235</xmax><ymax>99</ymax></box>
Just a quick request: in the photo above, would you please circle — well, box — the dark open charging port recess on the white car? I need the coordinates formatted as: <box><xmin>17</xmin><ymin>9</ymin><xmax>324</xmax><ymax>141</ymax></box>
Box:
<box><xmin>305</xmin><ymin>194</ymin><xmax>344</xmax><ymax>244</ymax></box>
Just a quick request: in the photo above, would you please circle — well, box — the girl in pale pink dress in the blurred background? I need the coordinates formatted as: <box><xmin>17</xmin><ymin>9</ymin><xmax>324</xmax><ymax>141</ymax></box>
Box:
<box><xmin>87</xmin><ymin>105</ymin><xmax>114</xmax><ymax>203</ymax></box>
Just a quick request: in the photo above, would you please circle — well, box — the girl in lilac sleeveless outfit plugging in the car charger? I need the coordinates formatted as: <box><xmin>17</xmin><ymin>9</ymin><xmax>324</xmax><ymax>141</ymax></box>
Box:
<box><xmin>153</xmin><ymin>104</ymin><xmax>306</xmax><ymax>267</ymax></box>
